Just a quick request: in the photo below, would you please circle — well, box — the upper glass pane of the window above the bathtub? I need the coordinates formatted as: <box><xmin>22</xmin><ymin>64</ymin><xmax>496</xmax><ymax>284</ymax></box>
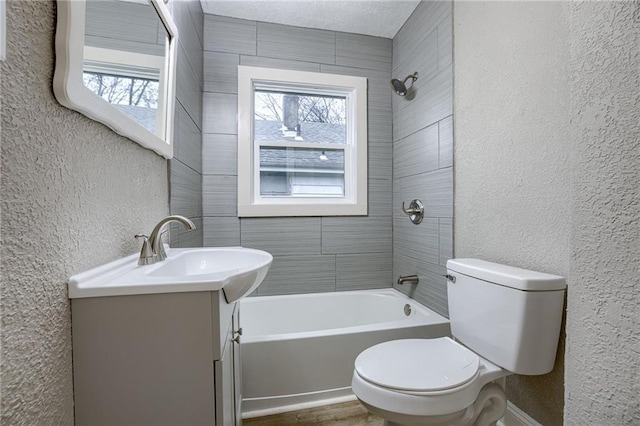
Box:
<box><xmin>254</xmin><ymin>90</ymin><xmax>347</xmax><ymax>144</ymax></box>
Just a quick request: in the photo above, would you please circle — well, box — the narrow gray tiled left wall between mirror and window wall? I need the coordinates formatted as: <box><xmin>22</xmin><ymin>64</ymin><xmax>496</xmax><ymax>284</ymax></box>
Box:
<box><xmin>169</xmin><ymin>0</ymin><xmax>204</xmax><ymax>247</ymax></box>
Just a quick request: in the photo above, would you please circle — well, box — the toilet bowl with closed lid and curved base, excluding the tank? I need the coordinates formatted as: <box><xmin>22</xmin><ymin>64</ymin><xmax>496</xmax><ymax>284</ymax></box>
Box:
<box><xmin>351</xmin><ymin>337</ymin><xmax>510</xmax><ymax>425</ymax></box>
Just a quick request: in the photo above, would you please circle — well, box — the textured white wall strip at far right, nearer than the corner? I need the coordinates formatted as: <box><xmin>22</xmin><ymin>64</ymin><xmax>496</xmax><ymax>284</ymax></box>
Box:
<box><xmin>565</xmin><ymin>1</ymin><xmax>640</xmax><ymax>426</ymax></box>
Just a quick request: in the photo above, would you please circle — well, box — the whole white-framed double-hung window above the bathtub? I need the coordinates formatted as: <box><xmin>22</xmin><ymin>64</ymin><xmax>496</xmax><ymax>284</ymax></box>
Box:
<box><xmin>238</xmin><ymin>66</ymin><xmax>367</xmax><ymax>217</ymax></box>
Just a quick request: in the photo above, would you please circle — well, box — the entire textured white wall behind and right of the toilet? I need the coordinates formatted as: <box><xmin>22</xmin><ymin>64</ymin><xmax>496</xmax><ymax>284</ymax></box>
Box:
<box><xmin>454</xmin><ymin>2</ymin><xmax>640</xmax><ymax>425</ymax></box>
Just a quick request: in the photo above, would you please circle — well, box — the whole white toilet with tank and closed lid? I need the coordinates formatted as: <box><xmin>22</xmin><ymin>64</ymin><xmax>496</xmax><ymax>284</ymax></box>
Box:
<box><xmin>351</xmin><ymin>259</ymin><xmax>566</xmax><ymax>426</ymax></box>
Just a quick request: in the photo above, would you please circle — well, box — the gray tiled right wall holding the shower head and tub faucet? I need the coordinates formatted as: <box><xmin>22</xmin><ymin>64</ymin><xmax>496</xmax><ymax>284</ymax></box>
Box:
<box><xmin>393</xmin><ymin>2</ymin><xmax>453</xmax><ymax>316</ymax></box>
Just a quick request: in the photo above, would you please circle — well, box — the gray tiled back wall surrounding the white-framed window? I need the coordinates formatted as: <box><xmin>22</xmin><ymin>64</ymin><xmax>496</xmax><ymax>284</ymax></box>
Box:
<box><xmin>202</xmin><ymin>15</ymin><xmax>396</xmax><ymax>295</ymax></box>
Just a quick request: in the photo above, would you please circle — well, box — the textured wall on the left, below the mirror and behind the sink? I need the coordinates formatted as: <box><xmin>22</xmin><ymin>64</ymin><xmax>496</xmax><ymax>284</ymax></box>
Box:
<box><xmin>0</xmin><ymin>1</ymin><xmax>168</xmax><ymax>425</ymax></box>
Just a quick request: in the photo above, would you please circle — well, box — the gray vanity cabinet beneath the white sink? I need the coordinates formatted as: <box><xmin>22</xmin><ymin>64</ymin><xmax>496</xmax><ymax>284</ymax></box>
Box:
<box><xmin>71</xmin><ymin>291</ymin><xmax>242</xmax><ymax>426</ymax></box>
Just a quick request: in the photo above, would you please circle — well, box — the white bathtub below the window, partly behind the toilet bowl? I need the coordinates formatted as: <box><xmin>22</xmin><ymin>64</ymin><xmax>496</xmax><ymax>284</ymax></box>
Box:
<box><xmin>240</xmin><ymin>289</ymin><xmax>450</xmax><ymax>418</ymax></box>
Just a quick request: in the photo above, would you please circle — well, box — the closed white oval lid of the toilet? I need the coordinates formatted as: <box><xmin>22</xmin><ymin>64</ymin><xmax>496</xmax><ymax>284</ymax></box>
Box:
<box><xmin>355</xmin><ymin>337</ymin><xmax>480</xmax><ymax>392</ymax></box>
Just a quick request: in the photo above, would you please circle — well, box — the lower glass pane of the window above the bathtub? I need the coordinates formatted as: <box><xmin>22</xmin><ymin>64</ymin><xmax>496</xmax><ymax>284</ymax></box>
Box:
<box><xmin>260</xmin><ymin>146</ymin><xmax>344</xmax><ymax>197</ymax></box>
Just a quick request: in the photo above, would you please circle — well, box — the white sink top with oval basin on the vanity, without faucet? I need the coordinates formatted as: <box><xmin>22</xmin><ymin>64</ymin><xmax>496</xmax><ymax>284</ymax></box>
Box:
<box><xmin>69</xmin><ymin>247</ymin><xmax>273</xmax><ymax>303</ymax></box>
